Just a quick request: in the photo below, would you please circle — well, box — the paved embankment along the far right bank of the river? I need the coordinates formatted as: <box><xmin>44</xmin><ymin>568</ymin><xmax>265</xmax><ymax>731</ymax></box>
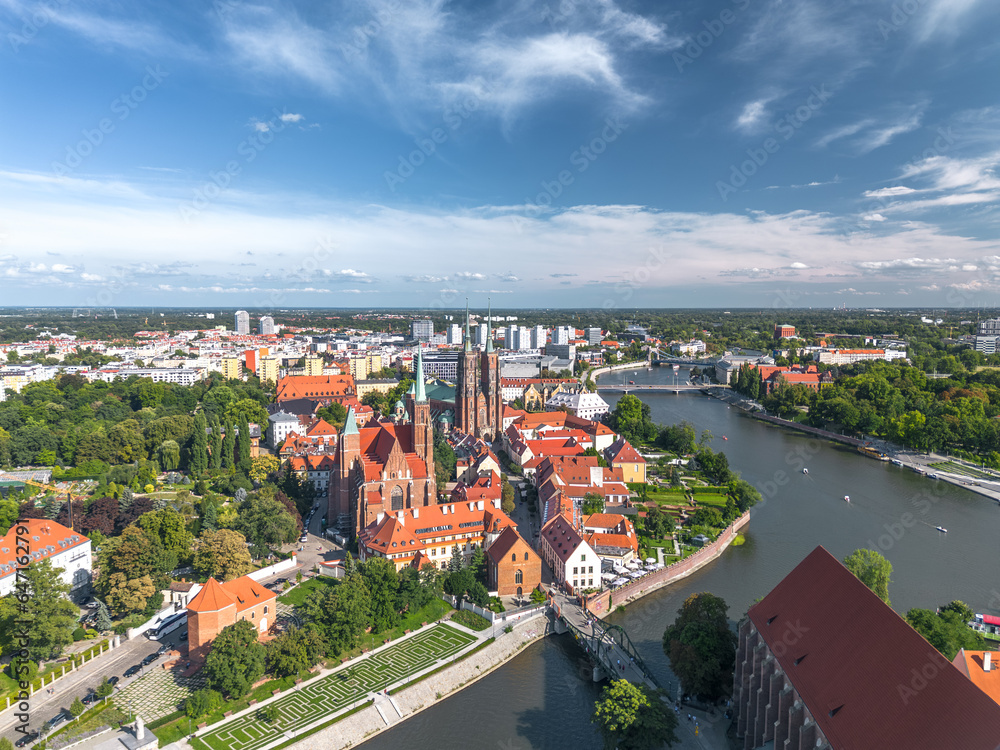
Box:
<box><xmin>705</xmin><ymin>388</ymin><xmax>1000</xmax><ymax>503</ymax></box>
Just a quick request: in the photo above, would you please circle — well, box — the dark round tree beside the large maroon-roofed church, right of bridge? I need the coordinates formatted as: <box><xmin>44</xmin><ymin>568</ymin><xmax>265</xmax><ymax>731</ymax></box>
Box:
<box><xmin>663</xmin><ymin>592</ymin><xmax>736</xmax><ymax>701</ymax></box>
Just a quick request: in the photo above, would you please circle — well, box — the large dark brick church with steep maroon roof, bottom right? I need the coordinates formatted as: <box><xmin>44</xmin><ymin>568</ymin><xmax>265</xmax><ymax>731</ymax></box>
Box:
<box><xmin>733</xmin><ymin>547</ymin><xmax>1000</xmax><ymax>750</ymax></box>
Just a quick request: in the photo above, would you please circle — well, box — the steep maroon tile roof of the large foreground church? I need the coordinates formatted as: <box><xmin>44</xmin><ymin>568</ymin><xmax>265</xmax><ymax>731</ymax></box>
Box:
<box><xmin>749</xmin><ymin>547</ymin><xmax>1000</xmax><ymax>750</ymax></box>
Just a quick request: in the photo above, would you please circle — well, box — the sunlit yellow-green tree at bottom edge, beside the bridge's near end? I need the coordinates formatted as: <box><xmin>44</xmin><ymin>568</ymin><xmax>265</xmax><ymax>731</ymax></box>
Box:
<box><xmin>593</xmin><ymin>680</ymin><xmax>677</xmax><ymax>750</ymax></box>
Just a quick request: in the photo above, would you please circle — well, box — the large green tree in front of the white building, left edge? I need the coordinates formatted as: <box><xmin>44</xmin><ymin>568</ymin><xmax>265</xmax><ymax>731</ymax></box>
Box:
<box><xmin>0</xmin><ymin>558</ymin><xmax>77</xmax><ymax>662</ymax></box>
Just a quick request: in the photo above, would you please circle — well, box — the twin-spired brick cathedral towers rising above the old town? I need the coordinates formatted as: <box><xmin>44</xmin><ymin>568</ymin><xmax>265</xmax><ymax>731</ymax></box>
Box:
<box><xmin>455</xmin><ymin>305</ymin><xmax>503</xmax><ymax>442</ymax></box>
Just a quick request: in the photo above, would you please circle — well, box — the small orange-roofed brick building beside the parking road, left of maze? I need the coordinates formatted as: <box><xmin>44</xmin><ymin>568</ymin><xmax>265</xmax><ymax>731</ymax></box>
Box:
<box><xmin>187</xmin><ymin>576</ymin><xmax>277</xmax><ymax>659</ymax></box>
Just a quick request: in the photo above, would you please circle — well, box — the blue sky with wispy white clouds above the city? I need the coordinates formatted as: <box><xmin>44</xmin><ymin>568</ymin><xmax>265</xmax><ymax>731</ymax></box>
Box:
<box><xmin>0</xmin><ymin>0</ymin><xmax>1000</xmax><ymax>309</ymax></box>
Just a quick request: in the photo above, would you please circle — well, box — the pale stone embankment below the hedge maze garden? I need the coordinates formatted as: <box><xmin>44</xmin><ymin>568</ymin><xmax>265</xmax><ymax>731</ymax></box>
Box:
<box><xmin>289</xmin><ymin>616</ymin><xmax>551</xmax><ymax>750</ymax></box>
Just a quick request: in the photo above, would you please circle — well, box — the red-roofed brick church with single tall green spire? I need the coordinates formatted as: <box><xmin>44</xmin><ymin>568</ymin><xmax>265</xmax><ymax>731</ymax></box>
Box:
<box><xmin>327</xmin><ymin>353</ymin><xmax>437</xmax><ymax>535</ymax></box>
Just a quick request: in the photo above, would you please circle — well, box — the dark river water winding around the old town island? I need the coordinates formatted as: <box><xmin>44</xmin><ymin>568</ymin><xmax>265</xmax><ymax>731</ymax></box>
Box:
<box><xmin>364</xmin><ymin>368</ymin><xmax>1000</xmax><ymax>750</ymax></box>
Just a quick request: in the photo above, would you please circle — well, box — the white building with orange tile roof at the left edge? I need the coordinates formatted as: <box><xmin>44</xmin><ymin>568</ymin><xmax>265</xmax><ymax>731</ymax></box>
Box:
<box><xmin>0</xmin><ymin>518</ymin><xmax>92</xmax><ymax>596</ymax></box>
